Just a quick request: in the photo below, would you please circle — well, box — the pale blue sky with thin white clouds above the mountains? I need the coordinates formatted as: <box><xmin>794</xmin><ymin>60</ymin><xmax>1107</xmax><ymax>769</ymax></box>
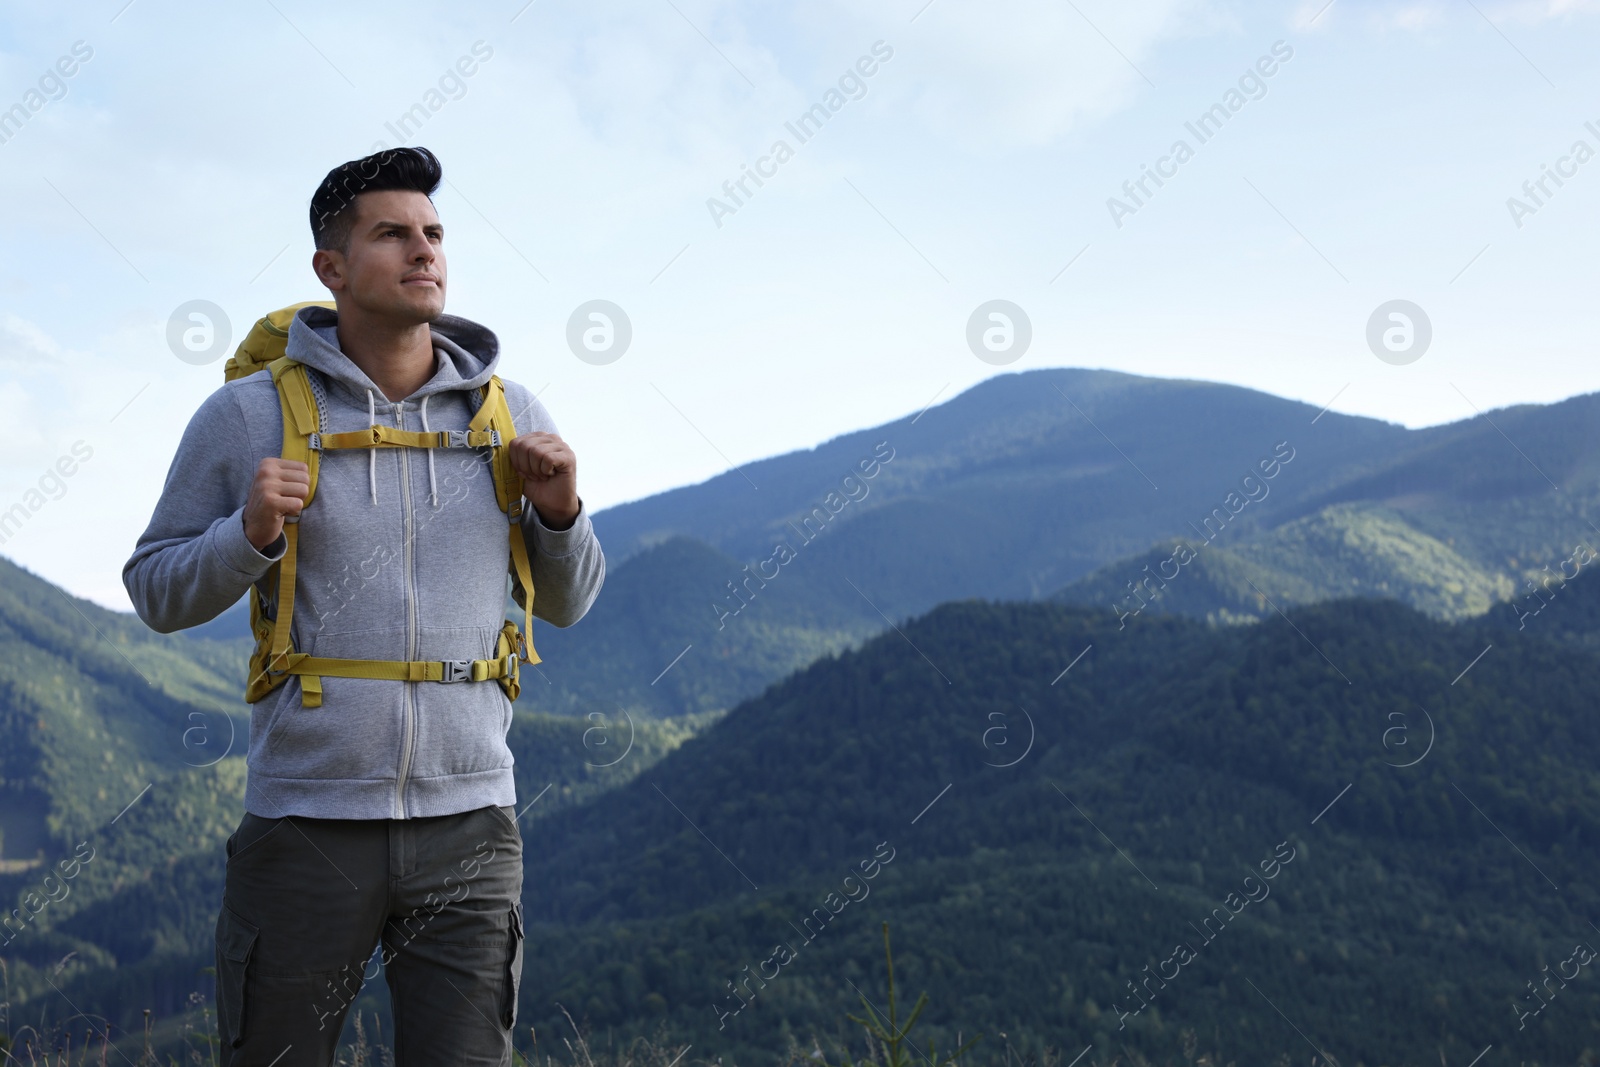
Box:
<box><xmin>0</xmin><ymin>0</ymin><xmax>1600</xmax><ymax>609</ymax></box>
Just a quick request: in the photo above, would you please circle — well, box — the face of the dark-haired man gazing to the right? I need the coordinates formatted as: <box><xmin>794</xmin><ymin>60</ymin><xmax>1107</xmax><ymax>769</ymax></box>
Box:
<box><xmin>312</xmin><ymin>189</ymin><xmax>446</xmax><ymax>325</ymax></box>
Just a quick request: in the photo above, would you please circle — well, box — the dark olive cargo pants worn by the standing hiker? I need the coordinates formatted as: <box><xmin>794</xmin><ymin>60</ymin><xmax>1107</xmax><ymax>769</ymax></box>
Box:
<box><xmin>216</xmin><ymin>806</ymin><xmax>523</xmax><ymax>1067</ymax></box>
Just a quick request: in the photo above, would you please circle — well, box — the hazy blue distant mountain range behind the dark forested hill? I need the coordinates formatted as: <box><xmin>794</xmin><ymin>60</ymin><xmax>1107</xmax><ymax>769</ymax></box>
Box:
<box><xmin>181</xmin><ymin>368</ymin><xmax>1600</xmax><ymax>717</ymax></box>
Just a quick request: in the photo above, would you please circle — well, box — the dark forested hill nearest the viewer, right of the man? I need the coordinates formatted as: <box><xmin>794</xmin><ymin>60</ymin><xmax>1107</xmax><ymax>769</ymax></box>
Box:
<box><xmin>505</xmin><ymin>577</ymin><xmax>1600</xmax><ymax>1064</ymax></box>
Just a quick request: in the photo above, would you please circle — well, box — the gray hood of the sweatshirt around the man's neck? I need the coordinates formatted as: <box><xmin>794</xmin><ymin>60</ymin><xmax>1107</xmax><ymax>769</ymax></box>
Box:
<box><xmin>285</xmin><ymin>307</ymin><xmax>499</xmax><ymax>408</ymax></box>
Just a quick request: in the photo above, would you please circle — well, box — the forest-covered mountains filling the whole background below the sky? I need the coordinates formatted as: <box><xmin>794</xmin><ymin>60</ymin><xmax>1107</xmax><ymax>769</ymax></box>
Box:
<box><xmin>9</xmin><ymin>370</ymin><xmax>1600</xmax><ymax>1067</ymax></box>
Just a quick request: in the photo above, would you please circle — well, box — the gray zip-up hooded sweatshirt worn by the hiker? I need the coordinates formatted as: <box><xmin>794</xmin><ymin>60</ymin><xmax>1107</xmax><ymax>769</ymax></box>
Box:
<box><xmin>123</xmin><ymin>307</ymin><xmax>605</xmax><ymax>819</ymax></box>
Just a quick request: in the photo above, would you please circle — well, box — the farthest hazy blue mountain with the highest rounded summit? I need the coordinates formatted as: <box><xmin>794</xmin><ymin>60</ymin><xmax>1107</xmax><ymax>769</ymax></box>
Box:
<box><xmin>594</xmin><ymin>368</ymin><xmax>1411</xmax><ymax>588</ymax></box>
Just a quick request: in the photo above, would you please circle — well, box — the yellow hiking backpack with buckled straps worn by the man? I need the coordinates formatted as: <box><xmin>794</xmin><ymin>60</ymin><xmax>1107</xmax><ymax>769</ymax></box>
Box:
<box><xmin>222</xmin><ymin>301</ymin><xmax>541</xmax><ymax>707</ymax></box>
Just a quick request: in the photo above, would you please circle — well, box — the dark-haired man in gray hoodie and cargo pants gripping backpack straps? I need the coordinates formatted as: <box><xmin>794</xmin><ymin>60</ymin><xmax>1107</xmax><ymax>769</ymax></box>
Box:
<box><xmin>123</xmin><ymin>149</ymin><xmax>605</xmax><ymax>1067</ymax></box>
